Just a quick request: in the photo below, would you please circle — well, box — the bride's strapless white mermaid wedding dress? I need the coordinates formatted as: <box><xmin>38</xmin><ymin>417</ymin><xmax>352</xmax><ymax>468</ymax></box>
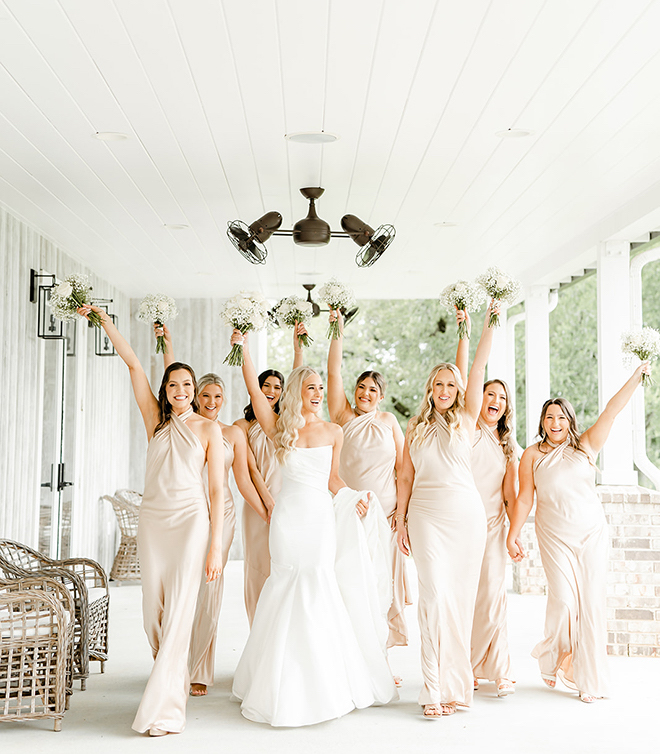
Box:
<box><xmin>233</xmin><ymin>446</ymin><xmax>396</xmax><ymax>727</ymax></box>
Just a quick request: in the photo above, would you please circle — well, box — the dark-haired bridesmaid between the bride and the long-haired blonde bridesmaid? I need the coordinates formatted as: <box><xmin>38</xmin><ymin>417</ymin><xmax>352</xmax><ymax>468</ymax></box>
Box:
<box><xmin>328</xmin><ymin>311</ymin><xmax>411</xmax><ymax>656</ymax></box>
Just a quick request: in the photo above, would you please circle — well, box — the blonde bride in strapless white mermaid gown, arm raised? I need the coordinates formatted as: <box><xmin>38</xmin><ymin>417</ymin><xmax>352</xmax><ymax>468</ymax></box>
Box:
<box><xmin>232</xmin><ymin>330</ymin><xmax>396</xmax><ymax>727</ymax></box>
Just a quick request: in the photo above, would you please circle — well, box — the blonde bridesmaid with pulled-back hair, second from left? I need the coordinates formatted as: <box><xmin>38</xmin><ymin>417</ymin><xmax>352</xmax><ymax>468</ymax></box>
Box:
<box><xmin>154</xmin><ymin>326</ymin><xmax>268</xmax><ymax>696</ymax></box>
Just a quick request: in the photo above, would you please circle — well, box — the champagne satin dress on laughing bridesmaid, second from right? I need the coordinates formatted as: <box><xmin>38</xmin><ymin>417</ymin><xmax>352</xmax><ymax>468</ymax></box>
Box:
<box><xmin>472</xmin><ymin>419</ymin><xmax>510</xmax><ymax>681</ymax></box>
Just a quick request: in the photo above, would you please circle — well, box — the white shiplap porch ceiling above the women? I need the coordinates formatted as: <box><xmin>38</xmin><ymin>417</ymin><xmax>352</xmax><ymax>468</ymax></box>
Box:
<box><xmin>0</xmin><ymin>0</ymin><xmax>660</xmax><ymax>298</ymax></box>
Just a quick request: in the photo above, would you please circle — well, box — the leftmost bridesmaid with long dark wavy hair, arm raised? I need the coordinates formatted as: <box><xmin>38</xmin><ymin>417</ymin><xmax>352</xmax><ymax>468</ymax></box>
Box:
<box><xmin>78</xmin><ymin>306</ymin><xmax>224</xmax><ymax>736</ymax></box>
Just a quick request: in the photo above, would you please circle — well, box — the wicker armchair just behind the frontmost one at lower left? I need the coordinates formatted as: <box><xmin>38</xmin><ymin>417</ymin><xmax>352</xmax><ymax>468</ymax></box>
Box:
<box><xmin>0</xmin><ymin>539</ymin><xmax>110</xmax><ymax>690</ymax></box>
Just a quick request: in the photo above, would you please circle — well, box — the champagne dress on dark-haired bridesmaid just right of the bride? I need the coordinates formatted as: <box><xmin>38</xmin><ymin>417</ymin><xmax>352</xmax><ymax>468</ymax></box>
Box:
<box><xmin>339</xmin><ymin>411</ymin><xmax>412</xmax><ymax>647</ymax></box>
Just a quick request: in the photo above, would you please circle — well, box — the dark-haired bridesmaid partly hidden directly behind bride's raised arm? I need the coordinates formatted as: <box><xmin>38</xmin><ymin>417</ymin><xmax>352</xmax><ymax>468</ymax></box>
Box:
<box><xmin>234</xmin><ymin>325</ymin><xmax>306</xmax><ymax>626</ymax></box>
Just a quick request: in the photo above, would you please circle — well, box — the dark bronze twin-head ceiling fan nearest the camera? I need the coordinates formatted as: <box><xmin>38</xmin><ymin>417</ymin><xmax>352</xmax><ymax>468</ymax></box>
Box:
<box><xmin>227</xmin><ymin>186</ymin><xmax>396</xmax><ymax>267</ymax></box>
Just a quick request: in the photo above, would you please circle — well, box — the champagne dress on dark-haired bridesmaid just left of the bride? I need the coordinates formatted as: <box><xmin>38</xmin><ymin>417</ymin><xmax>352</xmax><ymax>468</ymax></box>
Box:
<box><xmin>243</xmin><ymin>421</ymin><xmax>282</xmax><ymax>626</ymax></box>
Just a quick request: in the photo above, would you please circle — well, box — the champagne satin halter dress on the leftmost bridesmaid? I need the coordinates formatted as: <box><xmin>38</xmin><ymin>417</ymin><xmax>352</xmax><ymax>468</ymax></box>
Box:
<box><xmin>133</xmin><ymin>409</ymin><xmax>209</xmax><ymax>733</ymax></box>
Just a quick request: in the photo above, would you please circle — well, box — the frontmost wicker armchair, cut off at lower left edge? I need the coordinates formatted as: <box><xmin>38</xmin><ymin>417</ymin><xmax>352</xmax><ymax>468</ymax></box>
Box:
<box><xmin>0</xmin><ymin>579</ymin><xmax>73</xmax><ymax>731</ymax></box>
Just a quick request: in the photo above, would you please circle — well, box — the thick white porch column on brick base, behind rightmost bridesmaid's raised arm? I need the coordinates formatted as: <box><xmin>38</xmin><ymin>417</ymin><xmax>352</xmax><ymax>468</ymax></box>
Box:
<box><xmin>597</xmin><ymin>241</ymin><xmax>637</xmax><ymax>484</ymax></box>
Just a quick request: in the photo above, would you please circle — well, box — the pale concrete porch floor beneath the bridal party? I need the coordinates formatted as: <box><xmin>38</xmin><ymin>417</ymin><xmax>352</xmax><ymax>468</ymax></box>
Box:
<box><xmin>0</xmin><ymin>561</ymin><xmax>660</xmax><ymax>754</ymax></box>
